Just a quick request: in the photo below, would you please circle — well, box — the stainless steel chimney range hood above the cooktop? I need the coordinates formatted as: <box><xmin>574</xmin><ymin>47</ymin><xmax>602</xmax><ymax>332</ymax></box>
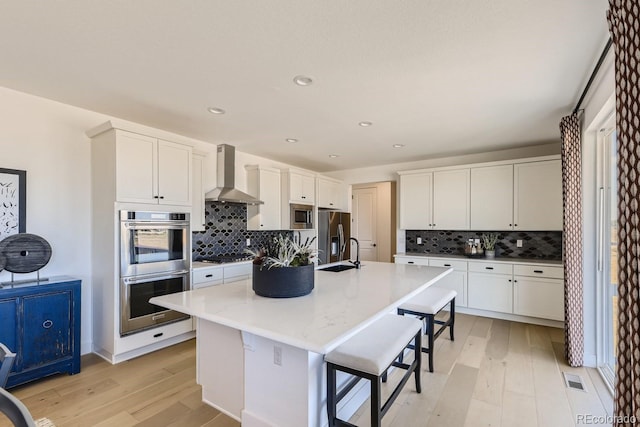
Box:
<box><xmin>204</xmin><ymin>144</ymin><xmax>264</xmax><ymax>205</ymax></box>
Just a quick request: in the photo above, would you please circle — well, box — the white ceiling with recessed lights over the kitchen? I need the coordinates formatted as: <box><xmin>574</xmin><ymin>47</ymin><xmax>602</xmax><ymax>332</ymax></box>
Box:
<box><xmin>0</xmin><ymin>0</ymin><xmax>608</xmax><ymax>172</ymax></box>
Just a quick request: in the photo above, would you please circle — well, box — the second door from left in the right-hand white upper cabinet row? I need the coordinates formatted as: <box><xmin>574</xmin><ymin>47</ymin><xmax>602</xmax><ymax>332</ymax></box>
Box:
<box><xmin>433</xmin><ymin>169</ymin><xmax>470</xmax><ymax>230</ymax></box>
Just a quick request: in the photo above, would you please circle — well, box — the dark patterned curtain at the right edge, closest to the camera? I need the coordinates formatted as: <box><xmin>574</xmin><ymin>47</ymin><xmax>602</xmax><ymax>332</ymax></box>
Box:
<box><xmin>607</xmin><ymin>0</ymin><xmax>640</xmax><ymax>426</ymax></box>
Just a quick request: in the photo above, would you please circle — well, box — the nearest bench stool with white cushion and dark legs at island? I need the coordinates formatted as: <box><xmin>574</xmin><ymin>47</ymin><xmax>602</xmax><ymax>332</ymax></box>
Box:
<box><xmin>324</xmin><ymin>315</ymin><xmax>422</xmax><ymax>427</ymax></box>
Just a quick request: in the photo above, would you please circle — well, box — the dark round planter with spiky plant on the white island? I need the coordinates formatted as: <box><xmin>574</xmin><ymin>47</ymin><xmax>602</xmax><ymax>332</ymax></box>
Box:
<box><xmin>247</xmin><ymin>233</ymin><xmax>317</xmax><ymax>298</ymax></box>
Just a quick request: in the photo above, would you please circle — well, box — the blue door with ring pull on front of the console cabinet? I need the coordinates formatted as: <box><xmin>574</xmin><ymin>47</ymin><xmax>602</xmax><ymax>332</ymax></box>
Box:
<box><xmin>22</xmin><ymin>292</ymin><xmax>73</xmax><ymax>370</ymax></box>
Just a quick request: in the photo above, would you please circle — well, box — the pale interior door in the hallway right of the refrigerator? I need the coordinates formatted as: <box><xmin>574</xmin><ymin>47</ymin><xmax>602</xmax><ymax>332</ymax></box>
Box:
<box><xmin>351</xmin><ymin>187</ymin><xmax>378</xmax><ymax>261</ymax></box>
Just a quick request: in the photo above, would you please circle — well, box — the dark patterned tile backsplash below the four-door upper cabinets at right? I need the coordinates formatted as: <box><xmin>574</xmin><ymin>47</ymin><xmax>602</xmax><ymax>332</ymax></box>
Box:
<box><xmin>406</xmin><ymin>230</ymin><xmax>562</xmax><ymax>260</ymax></box>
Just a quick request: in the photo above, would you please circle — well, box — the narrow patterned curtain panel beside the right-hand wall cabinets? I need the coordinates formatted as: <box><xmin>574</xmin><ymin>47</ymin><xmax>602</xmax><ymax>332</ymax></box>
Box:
<box><xmin>560</xmin><ymin>113</ymin><xmax>584</xmax><ymax>366</ymax></box>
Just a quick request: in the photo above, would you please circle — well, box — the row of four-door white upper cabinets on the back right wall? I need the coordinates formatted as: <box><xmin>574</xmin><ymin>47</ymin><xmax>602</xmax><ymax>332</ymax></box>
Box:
<box><xmin>398</xmin><ymin>156</ymin><xmax>562</xmax><ymax>231</ymax></box>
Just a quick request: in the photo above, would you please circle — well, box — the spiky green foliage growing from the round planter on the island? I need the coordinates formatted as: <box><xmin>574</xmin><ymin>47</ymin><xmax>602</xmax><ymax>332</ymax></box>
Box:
<box><xmin>245</xmin><ymin>232</ymin><xmax>318</xmax><ymax>269</ymax></box>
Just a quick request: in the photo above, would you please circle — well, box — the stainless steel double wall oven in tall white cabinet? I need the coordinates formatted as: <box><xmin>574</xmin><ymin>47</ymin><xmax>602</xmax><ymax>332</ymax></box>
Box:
<box><xmin>120</xmin><ymin>210</ymin><xmax>191</xmax><ymax>336</ymax></box>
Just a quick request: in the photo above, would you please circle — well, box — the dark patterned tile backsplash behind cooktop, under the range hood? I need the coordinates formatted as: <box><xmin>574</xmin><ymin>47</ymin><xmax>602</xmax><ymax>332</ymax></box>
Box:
<box><xmin>191</xmin><ymin>202</ymin><xmax>291</xmax><ymax>261</ymax></box>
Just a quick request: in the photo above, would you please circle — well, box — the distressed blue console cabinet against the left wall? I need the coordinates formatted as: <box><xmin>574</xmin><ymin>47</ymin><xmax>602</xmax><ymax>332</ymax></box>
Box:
<box><xmin>0</xmin><ymin>276</ymin><xmax>81</xmax><ymax>388</ymax></box>
